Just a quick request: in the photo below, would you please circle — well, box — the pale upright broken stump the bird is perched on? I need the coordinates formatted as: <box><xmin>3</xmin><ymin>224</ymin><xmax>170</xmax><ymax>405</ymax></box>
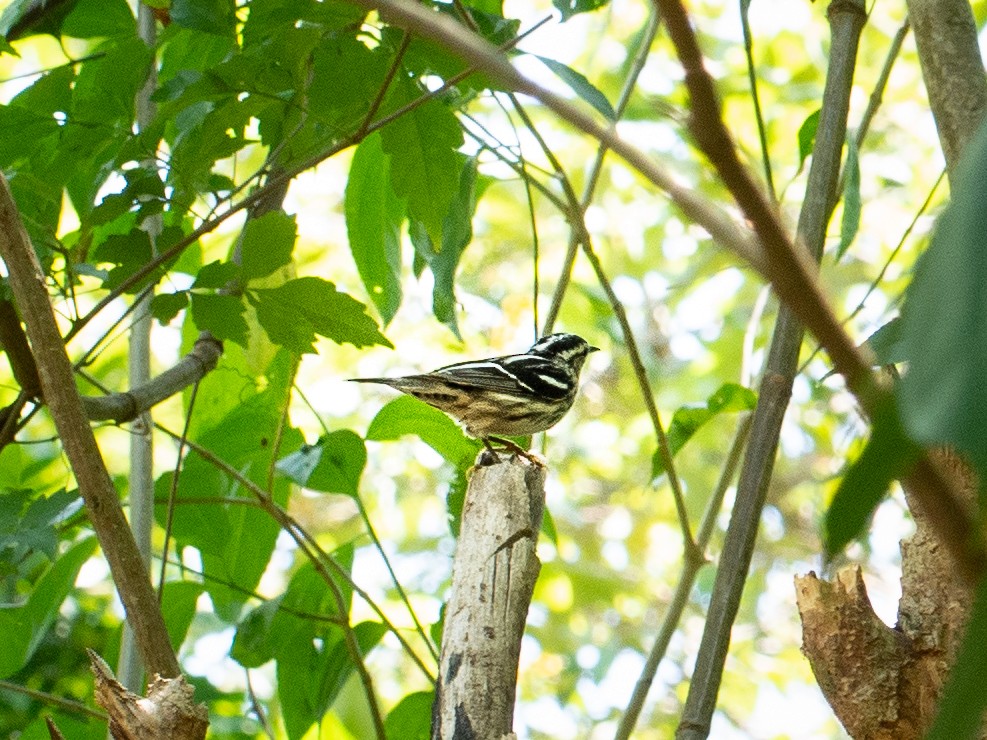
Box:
<box><xmin>432</xmin><ymin>457</ymin><xmax>545</xmax><ymax>740</ymax></box>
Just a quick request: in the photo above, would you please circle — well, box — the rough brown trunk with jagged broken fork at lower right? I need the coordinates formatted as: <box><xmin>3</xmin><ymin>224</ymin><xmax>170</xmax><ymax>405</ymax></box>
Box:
<box><xmin>795</xmin><ymin>450</ymin><xmax>985</xmax><ymax>740</ymax></box>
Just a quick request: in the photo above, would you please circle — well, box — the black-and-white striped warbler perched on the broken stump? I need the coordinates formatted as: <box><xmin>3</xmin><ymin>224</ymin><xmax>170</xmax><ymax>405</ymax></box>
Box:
<box><xmin>353</xmin><ymin>334</ymin><xmax>597</xmax><ymax>457</ymax></box>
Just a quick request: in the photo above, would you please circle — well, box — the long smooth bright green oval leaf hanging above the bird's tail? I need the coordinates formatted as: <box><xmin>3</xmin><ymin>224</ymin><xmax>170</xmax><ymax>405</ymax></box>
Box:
<box><xmin>346</xmin><ymin>134</ymin><xmax>404</xmax><ymax>326</ymax></box>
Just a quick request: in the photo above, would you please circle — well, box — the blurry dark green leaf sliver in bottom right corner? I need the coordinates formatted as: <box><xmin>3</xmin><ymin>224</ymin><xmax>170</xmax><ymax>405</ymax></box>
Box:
<box><xmin>926</xmin><ymin>578</ymin><xmax>987</xmax><ymax>740</ymax></box>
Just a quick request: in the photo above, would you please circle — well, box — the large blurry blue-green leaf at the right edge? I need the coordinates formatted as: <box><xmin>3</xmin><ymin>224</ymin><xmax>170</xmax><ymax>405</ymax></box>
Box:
<box><xmin>901</xmin><ymin>118</ymin><xmax>987</xmax><ymax>472</ymax></box>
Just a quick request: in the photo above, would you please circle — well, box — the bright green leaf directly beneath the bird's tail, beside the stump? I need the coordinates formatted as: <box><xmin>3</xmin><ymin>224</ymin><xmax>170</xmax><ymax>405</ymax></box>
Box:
<box><xmin>367</xmin><ymin>396</ymin><xmax>482</xmax><ymax>466</ymax></box>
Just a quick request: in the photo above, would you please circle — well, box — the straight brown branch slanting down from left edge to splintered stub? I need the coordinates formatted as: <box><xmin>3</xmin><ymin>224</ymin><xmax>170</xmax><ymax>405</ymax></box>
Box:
<box><xmin>0</xmin><ymin>171</ymin><xmax>179</xmax><ymax>677</ymax></box>
